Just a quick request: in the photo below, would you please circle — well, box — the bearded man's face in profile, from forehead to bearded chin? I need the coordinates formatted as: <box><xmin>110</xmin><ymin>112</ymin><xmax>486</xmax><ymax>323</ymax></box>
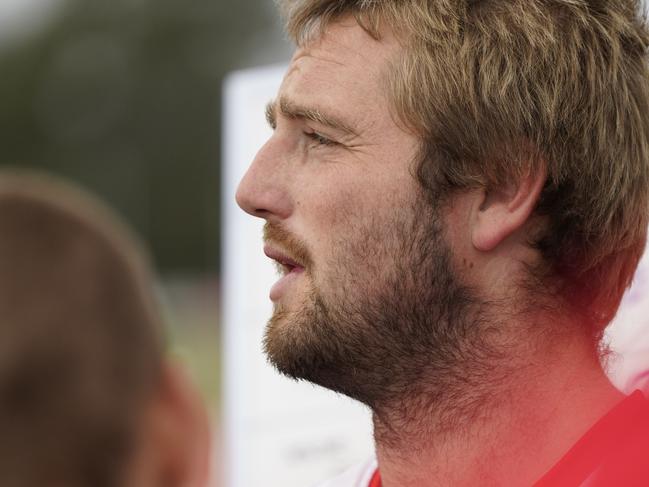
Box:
<box><xmin>237</xmin><ymin>20</ymin><xmax>474</xmax><ymax>405</ymax></box>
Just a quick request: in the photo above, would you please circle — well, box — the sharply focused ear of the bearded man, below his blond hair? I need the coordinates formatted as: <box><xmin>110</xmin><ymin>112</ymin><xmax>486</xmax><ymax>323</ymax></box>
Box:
<box><xmin>471</xmin><ymin>165</ymin><xmax>546</xmax><ymax>252</ymax></box>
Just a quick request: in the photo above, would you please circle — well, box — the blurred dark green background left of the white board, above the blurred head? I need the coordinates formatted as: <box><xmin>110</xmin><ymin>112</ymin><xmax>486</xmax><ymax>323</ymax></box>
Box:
<box><xmin>0</xmin><ymin>0</ymin><xmax>290</xmax><ymax>411</ymax></box>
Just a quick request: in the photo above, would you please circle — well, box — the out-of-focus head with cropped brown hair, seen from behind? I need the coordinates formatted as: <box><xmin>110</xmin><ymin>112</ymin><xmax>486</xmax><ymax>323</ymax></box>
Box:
<box><xmin>0</xmin><ymin>172</ymin><xmax>208</xmax><ymax>487</ymax></box>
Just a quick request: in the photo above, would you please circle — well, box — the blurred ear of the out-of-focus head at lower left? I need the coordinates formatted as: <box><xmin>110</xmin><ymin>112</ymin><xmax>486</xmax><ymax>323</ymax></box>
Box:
<box><xmin>133</xmin><ymin>364</ymin><xmax>211</xmax><ymax>487</ymax></box>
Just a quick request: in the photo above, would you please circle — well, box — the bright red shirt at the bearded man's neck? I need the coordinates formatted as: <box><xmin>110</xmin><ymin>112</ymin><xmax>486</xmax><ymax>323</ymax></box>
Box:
<box><xmin>368</xmin><ymin>391</ymin><xmax>649</xmax><ymax>487</ymax></box>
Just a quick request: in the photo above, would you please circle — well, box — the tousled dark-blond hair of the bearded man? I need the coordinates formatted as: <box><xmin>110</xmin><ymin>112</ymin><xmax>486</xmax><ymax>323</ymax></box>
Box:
<box><xmin>279</xmin><ymin>0</ymin><xmax>649</xmax><ymax>328</ymax></box>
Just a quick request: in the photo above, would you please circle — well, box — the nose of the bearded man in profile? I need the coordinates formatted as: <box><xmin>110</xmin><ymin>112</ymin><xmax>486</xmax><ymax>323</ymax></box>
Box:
<box><xmin>236</xmin><ymin>138</ymin><xmax>292</xmax><ymax>220</ymax></box>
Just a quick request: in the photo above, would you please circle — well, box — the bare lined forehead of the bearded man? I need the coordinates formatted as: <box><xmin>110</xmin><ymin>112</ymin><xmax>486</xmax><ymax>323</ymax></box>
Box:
<box><xmin>280</xmin><ymin>18</ymin><xmax>399</xmax><ymax>129</ymax></box>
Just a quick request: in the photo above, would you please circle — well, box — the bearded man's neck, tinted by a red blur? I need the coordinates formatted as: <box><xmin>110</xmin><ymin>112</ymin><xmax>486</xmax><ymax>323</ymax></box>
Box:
<box><xmin>374</xmin><ymin>316</ymin><xmax>622</xmax><ymax>487</ymax></box>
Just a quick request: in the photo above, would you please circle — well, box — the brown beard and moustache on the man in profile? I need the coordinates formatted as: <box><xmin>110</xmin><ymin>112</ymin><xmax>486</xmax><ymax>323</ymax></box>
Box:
<box><xmin>264</xmin><ymin>193</ymin><xmax>486</xmax><ymax>414</ymax></box>
